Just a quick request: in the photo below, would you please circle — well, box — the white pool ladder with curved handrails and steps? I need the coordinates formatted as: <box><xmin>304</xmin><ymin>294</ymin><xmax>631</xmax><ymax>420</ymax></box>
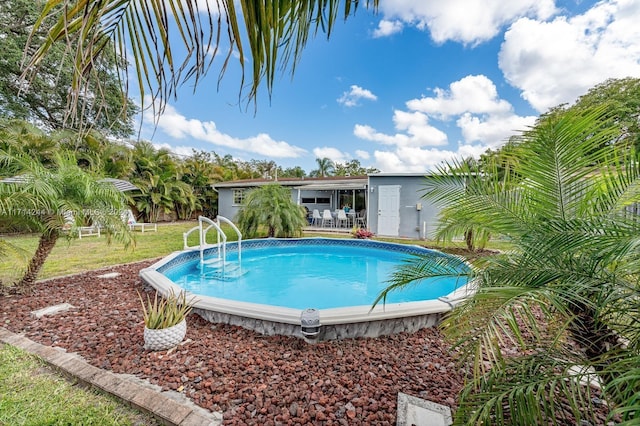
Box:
<box><xmin>183</xmin><ymin>216</ymin><xmax>244</xmax><ymax>281</ymax></box>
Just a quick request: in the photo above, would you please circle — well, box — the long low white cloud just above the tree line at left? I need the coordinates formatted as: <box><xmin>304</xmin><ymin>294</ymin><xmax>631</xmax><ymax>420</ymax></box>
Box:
<box><xmin>152</xmin><ymin>105</ymin><xmax>307</xmax><ymax>158</ymax></box>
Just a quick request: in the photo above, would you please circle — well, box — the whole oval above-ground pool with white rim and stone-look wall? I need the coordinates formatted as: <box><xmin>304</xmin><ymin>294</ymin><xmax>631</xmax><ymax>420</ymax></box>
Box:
<box><xmin>140</xmin><ymin>238</ymin><xmax>468</xmax><ymax>340</ymax></box>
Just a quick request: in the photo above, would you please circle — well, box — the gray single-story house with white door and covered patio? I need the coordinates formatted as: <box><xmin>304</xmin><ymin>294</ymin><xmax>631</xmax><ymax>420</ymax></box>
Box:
<box><xmin>214</xmin><ymin>173</ymin><xmax>439</xmax><ymax>239</ymax></box>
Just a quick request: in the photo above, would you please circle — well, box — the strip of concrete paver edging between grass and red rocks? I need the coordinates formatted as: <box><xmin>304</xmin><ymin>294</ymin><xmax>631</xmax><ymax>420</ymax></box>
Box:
<box><xmin>0</xmin><ymin>327</ymin><xmax>222</xmax><ymax>426</ymax></box>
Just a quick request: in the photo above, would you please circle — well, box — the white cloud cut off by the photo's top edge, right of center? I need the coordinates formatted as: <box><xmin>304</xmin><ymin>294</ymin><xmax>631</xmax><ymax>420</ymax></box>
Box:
<box><xmin>380</xmin><ymin>0</ymin><xmax>556</xmax><ymax>45</ymax></box>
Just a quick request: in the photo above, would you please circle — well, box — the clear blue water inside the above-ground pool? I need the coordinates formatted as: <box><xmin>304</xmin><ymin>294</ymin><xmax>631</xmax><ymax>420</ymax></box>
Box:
<box><xmin>162</xmin><ymin>240</ymin><xmax>466</xmax><ymax>309</ymax></box>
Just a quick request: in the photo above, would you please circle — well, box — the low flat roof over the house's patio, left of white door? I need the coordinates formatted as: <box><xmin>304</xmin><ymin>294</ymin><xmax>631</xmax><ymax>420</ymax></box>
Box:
<box><xmin>212</xmin><ymin>176</ymin><xmax>368</xmax><ymax>189</ymax></box>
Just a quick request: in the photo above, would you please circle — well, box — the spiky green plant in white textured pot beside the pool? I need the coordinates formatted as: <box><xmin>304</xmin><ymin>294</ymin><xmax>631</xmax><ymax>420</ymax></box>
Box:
<box><xmin>138</xmin><ymin>290</ymin><xmax>193</xmax><ymax>351</ymax></box>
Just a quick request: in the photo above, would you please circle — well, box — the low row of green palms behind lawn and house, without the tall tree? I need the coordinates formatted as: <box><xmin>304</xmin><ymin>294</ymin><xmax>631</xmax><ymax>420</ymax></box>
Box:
<box><xmin>0</xmin><ymin>118</ymin><xmax>377</xmax><ymax>222</ymax></box>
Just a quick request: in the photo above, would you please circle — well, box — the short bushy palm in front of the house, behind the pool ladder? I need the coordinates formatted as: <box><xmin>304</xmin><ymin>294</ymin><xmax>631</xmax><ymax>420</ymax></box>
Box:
<box><xmin>236</xmin><ymin>183</ymin><xmax>307</xmax><ymax>238</ymax></box>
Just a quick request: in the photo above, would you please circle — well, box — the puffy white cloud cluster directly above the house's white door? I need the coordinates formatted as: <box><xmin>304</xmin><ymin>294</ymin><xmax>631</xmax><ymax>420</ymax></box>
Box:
<box><xmin>353</xmin><ymin>76</ymin><xmax>536</xmax><ymax>172</ymax></box>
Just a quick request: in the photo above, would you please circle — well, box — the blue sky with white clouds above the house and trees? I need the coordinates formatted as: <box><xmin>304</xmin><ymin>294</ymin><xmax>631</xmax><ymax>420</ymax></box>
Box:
<box><xmin>141</xmin><ymin>0</ymin><xmax>640</xmax><ymax>173</ymax></box>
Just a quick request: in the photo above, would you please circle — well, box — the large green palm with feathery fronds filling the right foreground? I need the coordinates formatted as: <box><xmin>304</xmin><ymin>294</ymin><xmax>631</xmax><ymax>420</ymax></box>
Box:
<box><xmin>376</xmin><ymin>108</ymin><xmax>640</xmax><ymax>425</ymax></box>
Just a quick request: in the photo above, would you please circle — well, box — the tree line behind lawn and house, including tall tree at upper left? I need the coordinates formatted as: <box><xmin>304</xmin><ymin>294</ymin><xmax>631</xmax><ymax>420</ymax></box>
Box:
<box><xmin>0</xmin><ymin>0</ymin><xmax>377</xmax><ymax>222</ymax></box>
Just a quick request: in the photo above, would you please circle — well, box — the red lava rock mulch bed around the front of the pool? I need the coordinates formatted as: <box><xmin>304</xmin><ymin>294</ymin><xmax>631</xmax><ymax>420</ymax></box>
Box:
<box><xmin>0</xmin><ymin>262</ymin><xmax>463</xmax><ymax>425</ymax></box>
